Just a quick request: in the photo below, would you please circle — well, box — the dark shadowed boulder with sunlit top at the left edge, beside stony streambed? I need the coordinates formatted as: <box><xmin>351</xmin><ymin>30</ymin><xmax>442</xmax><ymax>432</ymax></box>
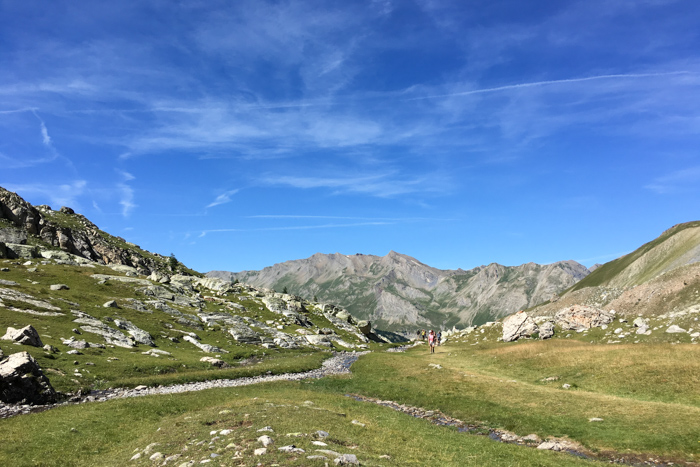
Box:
<box><xmin>0</xmin><ymin>352</ymin><xmax>58</xmax><ymax>404</ymax></box>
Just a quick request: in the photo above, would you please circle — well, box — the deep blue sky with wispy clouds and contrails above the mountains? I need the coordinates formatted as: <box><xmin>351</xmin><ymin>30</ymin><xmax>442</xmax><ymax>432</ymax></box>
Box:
<box><xmin>0</xmin><ymin>0</ymin><xmax>700</xmax><ymax>272</ymax></box>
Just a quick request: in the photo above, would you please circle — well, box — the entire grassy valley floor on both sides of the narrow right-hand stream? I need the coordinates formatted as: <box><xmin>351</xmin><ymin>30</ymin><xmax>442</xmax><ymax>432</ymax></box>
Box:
<box><xmin>0</xmin><ymin>339</ymin><xmax>700</xmax><ymax>466</ymax></box>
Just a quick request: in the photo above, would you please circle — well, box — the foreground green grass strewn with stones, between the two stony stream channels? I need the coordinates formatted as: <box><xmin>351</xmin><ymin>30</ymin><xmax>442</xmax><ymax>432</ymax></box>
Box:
<box><xmin>0</xmin><ymin>383</ymin><xmax>597</xmax><ymax>467</ymax></box>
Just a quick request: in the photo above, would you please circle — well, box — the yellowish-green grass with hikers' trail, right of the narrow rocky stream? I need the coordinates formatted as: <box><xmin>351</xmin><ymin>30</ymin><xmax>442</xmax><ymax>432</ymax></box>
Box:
<box><xmin>314</xmin><ymin>341</ymin><xmax>700</xmax><ymax>460</ymax></box>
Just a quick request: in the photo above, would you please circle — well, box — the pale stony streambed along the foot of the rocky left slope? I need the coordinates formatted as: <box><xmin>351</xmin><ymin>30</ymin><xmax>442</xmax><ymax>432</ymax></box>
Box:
<box><xmin>0</xmin><ymin>352</ymin><xmax>369</xmax><ymax>418</ymax></box>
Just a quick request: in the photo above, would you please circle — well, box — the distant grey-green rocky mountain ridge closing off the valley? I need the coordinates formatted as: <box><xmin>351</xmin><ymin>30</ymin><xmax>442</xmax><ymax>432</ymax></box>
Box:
<box><xmin>207</xmin><ymin>251</ymin><xmax>589</xmax><ymax>331</ymax></box>
